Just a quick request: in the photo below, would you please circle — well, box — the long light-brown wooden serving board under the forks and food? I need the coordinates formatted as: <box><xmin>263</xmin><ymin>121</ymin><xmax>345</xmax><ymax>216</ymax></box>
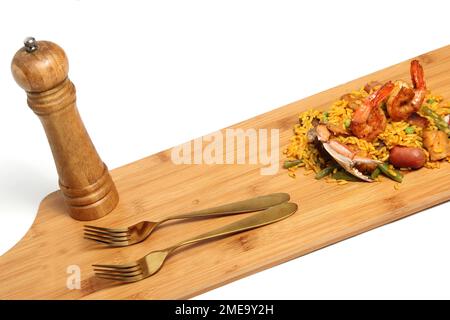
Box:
<box><xmin>0</xmin><ymin>46</ymin><xmax>450</xmax><ymax>299</ymax></box>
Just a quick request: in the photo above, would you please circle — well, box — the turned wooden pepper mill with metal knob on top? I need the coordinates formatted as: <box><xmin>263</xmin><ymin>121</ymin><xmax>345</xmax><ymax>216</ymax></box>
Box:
<box><xmin>11</xmin><ymin>38</ymin><xmax>119</xmax><ymax>220</ymax></box>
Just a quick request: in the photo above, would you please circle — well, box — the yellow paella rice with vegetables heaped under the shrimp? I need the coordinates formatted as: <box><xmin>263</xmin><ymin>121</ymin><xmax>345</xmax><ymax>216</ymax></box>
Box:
<box><xmin>284</xmin><ymin>61</ymin><xmax>450</xmax><ymax>184</ymax></box>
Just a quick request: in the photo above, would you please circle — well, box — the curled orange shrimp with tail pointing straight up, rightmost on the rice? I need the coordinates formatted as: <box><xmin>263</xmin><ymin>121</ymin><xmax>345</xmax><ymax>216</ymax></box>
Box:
<box><xmin>386</xmin><ymin>60</ymin><xmax>427</xmax><ymax>121</ymax></box>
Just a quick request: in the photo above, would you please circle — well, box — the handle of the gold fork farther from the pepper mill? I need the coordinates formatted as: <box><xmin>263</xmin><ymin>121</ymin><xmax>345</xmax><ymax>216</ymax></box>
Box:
<box><xmin>167</xmin><ymin>202</ymin><xmax>298</xmax><ymax>251</ymax></box>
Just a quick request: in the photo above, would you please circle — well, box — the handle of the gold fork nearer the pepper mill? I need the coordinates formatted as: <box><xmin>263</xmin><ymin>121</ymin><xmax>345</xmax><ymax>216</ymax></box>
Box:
<box><xmin>161</xmin><ymin>193</ymin><xmax>290</xmax><ymax>222</ymax></box>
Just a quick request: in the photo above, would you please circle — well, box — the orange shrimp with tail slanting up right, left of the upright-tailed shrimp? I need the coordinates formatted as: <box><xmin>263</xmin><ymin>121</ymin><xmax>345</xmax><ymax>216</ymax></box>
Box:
<box><xmin>350</xmin><ymin>81</ymin><xmax>394</xmax><ymax>141</ymax></box>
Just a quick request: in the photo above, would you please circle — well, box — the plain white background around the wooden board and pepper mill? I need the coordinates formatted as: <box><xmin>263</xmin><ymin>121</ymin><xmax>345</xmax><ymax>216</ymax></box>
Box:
<box><xmin>0</xmin><ymin>0</ymin><xmax>450</xmax><ymax>299</ymax></box>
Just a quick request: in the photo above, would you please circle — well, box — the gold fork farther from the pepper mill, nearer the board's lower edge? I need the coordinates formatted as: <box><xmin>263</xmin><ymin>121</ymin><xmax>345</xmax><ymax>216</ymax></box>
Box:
<box><xmin>93</xmin><ymin>202</ymin><xmax>298</xmax><ymax>283</ymax></box>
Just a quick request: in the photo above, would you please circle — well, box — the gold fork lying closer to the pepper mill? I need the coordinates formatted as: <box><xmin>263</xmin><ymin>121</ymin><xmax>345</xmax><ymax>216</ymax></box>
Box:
<box><xmin>84</xmin><ymin>193</ymin><xmax>290</xmax><ymax>247</ymax></box>
